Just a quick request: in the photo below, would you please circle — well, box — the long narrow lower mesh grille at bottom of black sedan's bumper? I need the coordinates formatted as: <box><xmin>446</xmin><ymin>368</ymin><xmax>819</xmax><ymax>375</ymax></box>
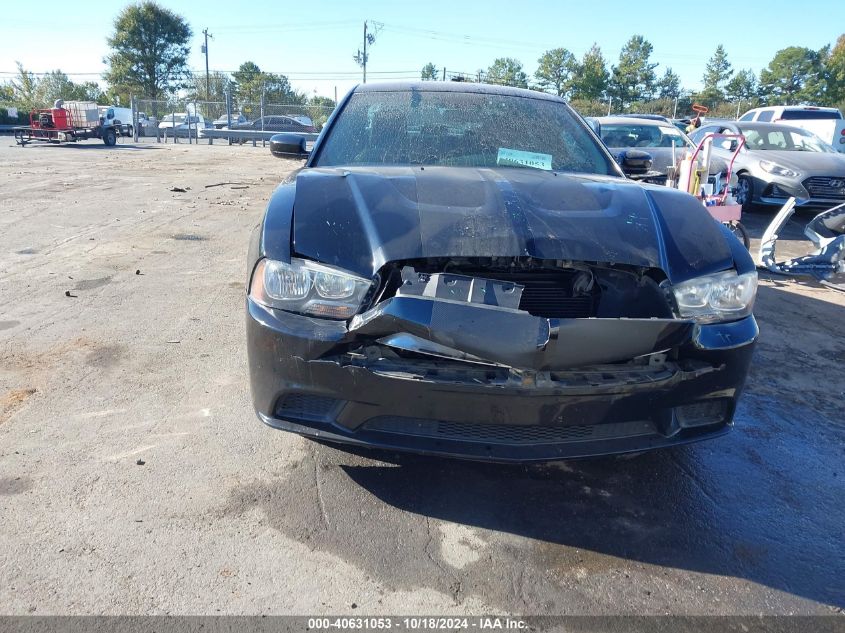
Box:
<box><xmin>364</xmin><ymin>416</ymin><xmax>655</xmax><ymax>445</ymax></box>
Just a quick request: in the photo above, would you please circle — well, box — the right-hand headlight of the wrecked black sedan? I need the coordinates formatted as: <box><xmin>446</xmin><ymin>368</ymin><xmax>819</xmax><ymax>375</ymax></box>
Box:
<box><xmin>672</xmin><ymin>270</ymin><xmax>757</xmax><ymax>323</ymax></box>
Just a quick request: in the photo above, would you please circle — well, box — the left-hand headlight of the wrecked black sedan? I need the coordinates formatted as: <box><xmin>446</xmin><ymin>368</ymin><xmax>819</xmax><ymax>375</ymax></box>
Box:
<box><xmin>249</xmin><ymin>257</ymin><xmax>373</xmax><ymax>319</ymax></box>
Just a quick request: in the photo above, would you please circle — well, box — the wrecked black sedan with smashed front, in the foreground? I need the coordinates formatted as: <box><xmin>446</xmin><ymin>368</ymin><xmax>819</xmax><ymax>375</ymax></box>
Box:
<box><xmin>247</xmin><ymin>82</ymin><xmax>758</xmax><ymax>461</ymax></box>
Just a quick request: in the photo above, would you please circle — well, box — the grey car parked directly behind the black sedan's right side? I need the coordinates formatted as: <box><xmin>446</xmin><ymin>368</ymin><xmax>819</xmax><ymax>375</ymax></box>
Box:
<box><xmin>593</xmin><ymin>116</ymin><xmax>695</xmax><ymax>184</ymax></box>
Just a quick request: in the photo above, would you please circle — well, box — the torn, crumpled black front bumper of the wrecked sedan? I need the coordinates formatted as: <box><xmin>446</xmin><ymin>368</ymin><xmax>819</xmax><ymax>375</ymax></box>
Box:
<box><xmin>247</xmin><ymin>296</ymin><xmax>758</xmax><ymax>461</ymax></box>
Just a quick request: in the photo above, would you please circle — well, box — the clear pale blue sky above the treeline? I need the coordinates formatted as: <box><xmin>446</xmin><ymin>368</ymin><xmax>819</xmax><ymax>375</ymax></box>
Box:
<box><xmin>0</xmin><ymin>0</ymin><xmax>845</xmax><ymax>97</ymax></box>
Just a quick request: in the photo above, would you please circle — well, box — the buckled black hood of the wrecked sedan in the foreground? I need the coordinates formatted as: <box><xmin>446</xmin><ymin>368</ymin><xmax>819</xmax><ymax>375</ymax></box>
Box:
<box><xmin>292</xmin><ymin>167</ymin><xmax>733</xmax><ymax>282</ymax></box>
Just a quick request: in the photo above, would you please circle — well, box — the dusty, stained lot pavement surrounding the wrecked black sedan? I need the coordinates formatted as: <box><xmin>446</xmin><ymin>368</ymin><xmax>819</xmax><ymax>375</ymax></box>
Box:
<box><xmin>0</xmin><ymin>138</ymin><xmax>845</xmax><ymax>615</ymax></box>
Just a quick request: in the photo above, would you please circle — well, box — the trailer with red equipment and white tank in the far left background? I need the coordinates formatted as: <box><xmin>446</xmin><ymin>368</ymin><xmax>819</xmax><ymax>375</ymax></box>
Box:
<box><xmin>15</xmin><ymin>100</ymin><xmax>120</xmax><ymax>146</ymax></box>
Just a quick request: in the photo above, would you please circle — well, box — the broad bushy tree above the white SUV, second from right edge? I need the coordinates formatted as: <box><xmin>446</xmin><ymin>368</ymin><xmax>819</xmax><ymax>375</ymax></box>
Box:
<box><xmin>760</xmin><ymin>46</ymin><xmax>827</xmax><ymax>105</ymax></box>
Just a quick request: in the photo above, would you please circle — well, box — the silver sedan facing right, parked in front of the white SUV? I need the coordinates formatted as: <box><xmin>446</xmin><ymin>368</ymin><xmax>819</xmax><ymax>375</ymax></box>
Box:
<box><xmin>691</xmin><ymin>121</ymin><xmax>845</xmax><ymax>211</ymax></box>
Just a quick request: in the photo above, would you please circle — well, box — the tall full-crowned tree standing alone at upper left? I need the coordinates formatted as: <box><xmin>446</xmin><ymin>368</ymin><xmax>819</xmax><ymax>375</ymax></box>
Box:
<box><xmin>103</xmin><ymin>1</ymin><xmax>192</xmax><ymax>99</ymax></box>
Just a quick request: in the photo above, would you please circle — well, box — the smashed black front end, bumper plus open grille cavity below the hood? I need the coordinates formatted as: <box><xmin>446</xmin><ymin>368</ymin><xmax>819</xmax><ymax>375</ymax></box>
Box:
<box><xmin>247</xmin><ymin>251</ymin><xmax>758</xmax><ymax>461</ymax></box>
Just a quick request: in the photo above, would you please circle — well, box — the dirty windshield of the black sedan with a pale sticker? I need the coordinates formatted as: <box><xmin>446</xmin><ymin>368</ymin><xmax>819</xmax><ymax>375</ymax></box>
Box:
<box><xmin>314</xmin><ymin>90</ymin><xmax>619</xmax><ymax>175</ymax></box>
